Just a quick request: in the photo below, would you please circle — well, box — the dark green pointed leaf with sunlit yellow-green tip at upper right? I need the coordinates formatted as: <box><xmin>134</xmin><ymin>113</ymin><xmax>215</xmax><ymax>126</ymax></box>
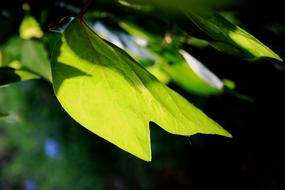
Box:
<box><xmin>185</xmin><ymin>11</ymin><xmax>283</xmax><ymax>61</ymax></box>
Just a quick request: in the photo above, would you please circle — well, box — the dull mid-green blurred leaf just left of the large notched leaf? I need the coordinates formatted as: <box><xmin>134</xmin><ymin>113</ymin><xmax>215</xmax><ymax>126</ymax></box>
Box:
<box><xmin>21</xmin><ymin>40</ymin><xmax>51</xmax><ymax>81</ymax></box>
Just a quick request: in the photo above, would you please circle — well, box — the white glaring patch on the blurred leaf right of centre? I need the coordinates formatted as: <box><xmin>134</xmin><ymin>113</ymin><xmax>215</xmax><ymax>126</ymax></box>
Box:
<box><xmin>179</xmin><ymin>50</ymin><xmax>224</xmax><ymax>89</ymax></box>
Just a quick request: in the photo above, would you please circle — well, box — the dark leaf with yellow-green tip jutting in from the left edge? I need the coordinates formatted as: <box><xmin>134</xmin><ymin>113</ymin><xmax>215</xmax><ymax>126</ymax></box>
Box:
<box><xmin>0</xmin><ymin>67</ymin><xmax>39</xmax><ymax>86</ymax></box>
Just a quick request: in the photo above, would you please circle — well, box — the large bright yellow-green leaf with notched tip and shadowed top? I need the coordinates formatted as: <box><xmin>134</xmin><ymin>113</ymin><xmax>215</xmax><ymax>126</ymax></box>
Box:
<box><xmin>51</xmin><ymin>19</ymin><xmax>231</xmax><ymax>161</ymax></box>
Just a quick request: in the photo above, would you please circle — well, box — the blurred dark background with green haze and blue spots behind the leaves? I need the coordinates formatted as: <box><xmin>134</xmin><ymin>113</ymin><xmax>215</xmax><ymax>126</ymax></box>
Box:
<box><xmin>0</xmin><ymin>0</ymin><xmax>285</xmax><ymax>190</ymax></box>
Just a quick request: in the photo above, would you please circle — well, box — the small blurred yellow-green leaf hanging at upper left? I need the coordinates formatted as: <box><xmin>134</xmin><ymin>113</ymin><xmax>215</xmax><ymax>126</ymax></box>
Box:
<box><xmin>19</xmin><ymin>15</ymin><xmax>44</xmax><ymax>39</ymax></box>
